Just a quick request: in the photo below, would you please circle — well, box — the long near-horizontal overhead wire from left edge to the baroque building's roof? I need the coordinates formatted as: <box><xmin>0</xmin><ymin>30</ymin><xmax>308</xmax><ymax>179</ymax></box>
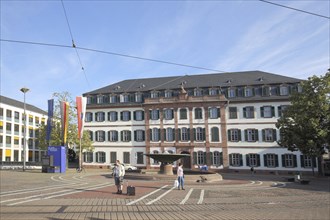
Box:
<box><xmin>0</xmin><ymin>39</ymin><xmax>227</xmax><ymax>73</ymax></box>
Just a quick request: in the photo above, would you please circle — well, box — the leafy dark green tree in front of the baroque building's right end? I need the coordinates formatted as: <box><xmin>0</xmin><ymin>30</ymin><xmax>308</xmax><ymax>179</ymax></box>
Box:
<box><xmin>276</xmin><ymin>72</ymin><xmax>330</xmax><ymax>173</ymax></box>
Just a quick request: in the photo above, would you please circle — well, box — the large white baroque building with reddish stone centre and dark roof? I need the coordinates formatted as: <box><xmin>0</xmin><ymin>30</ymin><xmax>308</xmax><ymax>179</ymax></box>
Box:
<box><xmin>83</xmin><ymin>71</ymin><xmax>317</xmax><ymax>172</ymax></box>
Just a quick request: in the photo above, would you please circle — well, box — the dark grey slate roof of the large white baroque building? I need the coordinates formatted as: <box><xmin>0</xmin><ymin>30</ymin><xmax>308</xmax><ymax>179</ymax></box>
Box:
<box><xmin>84</xmin><ymin>71</ymin><xmax>301</xmax><ymax>95</ymax></box>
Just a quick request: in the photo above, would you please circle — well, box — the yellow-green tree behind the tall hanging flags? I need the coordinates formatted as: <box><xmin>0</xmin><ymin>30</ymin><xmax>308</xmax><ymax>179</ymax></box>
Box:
<box><xmin>39</xmin><ymin>92</ymin><xmax>93</xmax><ymax>157</ymax></box>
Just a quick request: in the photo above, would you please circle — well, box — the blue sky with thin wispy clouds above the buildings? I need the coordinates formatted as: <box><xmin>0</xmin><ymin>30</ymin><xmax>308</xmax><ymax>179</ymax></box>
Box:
<box><xmin>0</xmin><ymin>0</ymin><xmax>330</xmax><ymax>110</ymax></box>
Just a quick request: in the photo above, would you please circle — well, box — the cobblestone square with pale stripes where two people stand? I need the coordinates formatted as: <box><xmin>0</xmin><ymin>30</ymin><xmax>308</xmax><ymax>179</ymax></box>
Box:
<box><xmin>0</xmin><ymin>170</ymin><xmax>330</xmax><ymax>220</ymax></box>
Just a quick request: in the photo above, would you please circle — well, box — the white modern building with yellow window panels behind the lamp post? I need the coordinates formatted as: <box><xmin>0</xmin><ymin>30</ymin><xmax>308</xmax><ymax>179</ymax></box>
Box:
<box><xmin>0</xmin><ymin>96</ymin><xmax>47</xmax><ymax>162</ymax></box>
